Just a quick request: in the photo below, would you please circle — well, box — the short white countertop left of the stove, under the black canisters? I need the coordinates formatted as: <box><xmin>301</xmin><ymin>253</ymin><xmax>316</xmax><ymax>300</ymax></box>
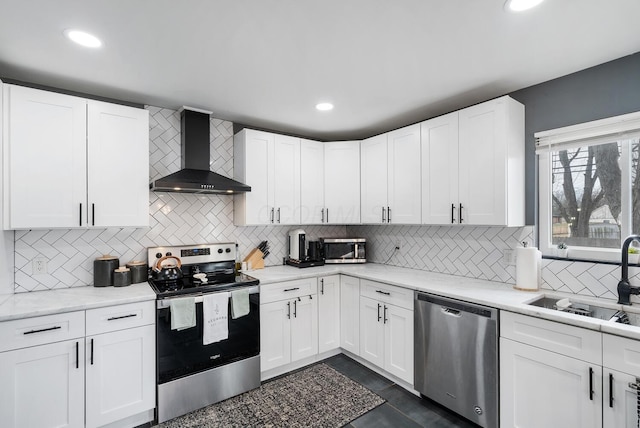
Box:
<box><xmin>0</xmin><ymin>282</ymin><xmax>156</xmax><ymax>321</ymax></box>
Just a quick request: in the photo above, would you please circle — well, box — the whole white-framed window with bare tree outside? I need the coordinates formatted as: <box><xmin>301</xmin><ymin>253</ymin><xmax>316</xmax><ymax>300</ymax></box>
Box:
<box><xmin>535</xmin><ymin>112</ymin><xmax>640</xmax><ymax>261</ymax></box>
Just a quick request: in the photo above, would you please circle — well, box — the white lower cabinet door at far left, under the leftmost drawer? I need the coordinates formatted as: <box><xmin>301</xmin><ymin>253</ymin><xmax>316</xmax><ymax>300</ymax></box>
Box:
<box><xmin>0</xmin><ymin>339</ymin><xmax>84</xmax><ymax>427</ymax></box>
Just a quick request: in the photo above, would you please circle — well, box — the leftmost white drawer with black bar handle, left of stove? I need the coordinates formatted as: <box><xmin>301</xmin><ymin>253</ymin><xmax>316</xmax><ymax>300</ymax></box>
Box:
<box><xmin>0</xmin><ymin>311</ymin><xmax>84</xmax><ymax>352</ymax></box>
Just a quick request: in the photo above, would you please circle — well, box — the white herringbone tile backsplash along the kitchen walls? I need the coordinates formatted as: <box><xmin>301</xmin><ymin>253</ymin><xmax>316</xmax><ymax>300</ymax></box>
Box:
<box><xmin>15</xmin><ymin>107</ymin><xmax>639</xmax><ymax>299</ymax></box>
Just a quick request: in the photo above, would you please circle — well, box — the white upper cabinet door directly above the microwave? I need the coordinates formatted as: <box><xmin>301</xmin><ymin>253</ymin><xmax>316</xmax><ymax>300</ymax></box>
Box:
<box><xmin>324</xmin><ymin>141</ymin><xmax>360</xmax><ymax>224</ymax></box>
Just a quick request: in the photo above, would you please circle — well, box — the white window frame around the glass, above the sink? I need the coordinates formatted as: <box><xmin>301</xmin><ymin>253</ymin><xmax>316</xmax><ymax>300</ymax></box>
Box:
<box><xmin>534</xmin><ymin>112</ymin><xmax>640</xmax><ymax>262</ymax></box>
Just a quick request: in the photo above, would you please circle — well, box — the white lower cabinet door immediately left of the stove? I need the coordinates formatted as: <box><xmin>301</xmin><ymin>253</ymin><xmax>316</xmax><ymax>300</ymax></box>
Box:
<box><xmin>86</xmin><ymin>325</ymin><xmax>156</xmax><ymax>427</ymax></box>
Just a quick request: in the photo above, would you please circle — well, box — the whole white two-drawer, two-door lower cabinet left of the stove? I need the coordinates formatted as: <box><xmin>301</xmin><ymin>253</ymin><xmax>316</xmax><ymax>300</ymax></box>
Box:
<box><xmin>0</xmin><ymin>301</ymin><xmax>156</xmax><ymax>427</ymax></box>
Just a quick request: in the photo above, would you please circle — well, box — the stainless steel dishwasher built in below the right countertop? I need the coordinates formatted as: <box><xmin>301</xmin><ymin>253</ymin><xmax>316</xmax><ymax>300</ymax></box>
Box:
<box><xmin>414</xmin><ymin>292</ymin><xmax>498</xmax><ymax>428</ymax></box>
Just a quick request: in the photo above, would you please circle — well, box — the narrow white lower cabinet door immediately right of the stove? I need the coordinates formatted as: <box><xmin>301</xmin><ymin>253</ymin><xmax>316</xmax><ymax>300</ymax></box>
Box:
<box><xmin>260</xmin><ymin>301</ymin><xmax>293</xmax><ymax>371</ymax></box>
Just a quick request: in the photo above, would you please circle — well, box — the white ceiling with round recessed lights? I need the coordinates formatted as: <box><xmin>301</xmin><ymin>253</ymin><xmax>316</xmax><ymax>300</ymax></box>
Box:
<box><xmin>0</xmin><ymin>0</ymin><xmax>640</xmax><ymax>140</ymax></box>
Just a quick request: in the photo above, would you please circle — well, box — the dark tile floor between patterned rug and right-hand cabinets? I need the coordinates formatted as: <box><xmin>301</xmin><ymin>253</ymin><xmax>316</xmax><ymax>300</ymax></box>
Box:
<box><xmin>323</xmin><ymin>354</ymin><xmax>477</xmax><ymax>428</ymax></box>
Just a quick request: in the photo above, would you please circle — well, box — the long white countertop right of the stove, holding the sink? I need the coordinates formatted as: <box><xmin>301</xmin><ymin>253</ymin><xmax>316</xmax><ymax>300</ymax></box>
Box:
<box><xmin>246</xmin><ymin>263</ymin><xmax>640</xmax><ymax>340</ymax></box>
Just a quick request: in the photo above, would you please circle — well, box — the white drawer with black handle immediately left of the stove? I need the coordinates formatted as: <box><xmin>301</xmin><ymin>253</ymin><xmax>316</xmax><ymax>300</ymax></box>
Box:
<box><xmin>87</xmin><ymin>300</ymin><xmax>156</xmax><ymax>336</ymax></box>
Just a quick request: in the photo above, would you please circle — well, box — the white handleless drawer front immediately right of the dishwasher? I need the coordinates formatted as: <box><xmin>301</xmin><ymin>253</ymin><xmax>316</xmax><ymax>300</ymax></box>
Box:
<box><xmin>500</xmin><ymin>311</ymin><xmax>602</xmax><ymax>365</ymax></box>
